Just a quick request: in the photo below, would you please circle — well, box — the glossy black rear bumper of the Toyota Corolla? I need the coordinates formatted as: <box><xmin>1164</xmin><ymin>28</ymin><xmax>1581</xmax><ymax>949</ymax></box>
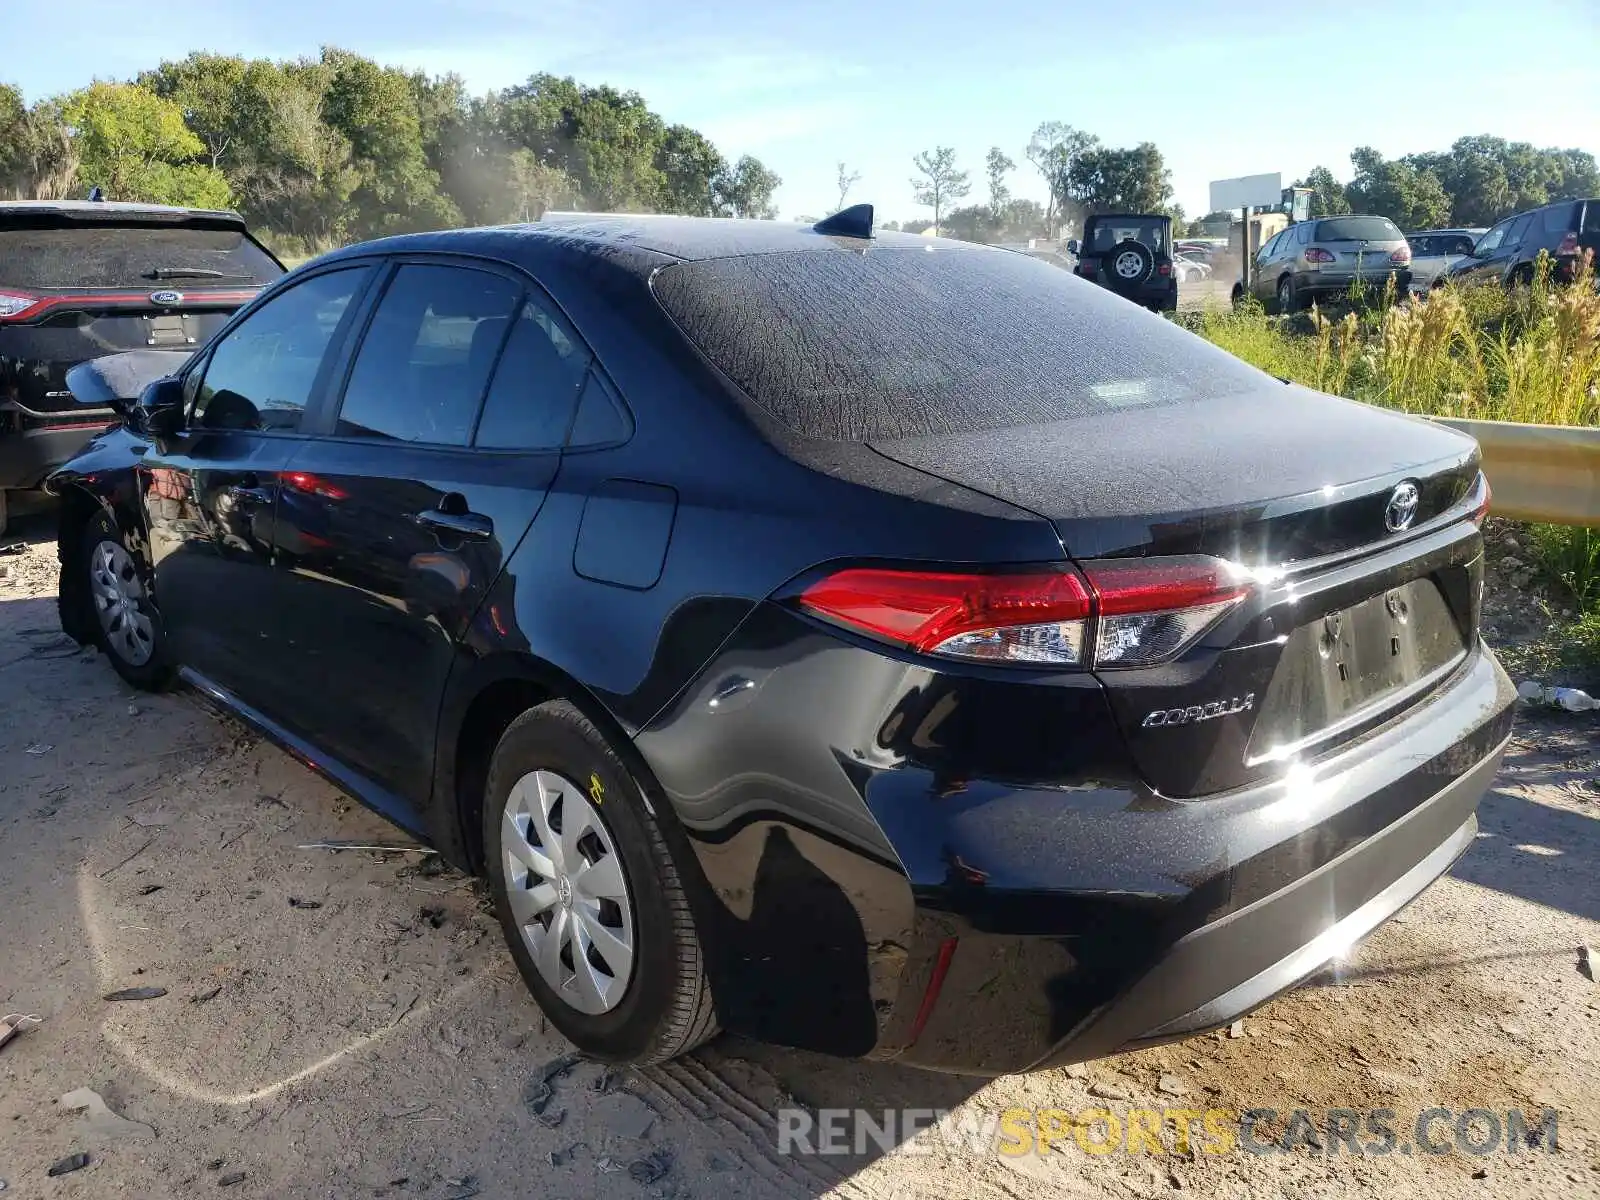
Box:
<box><xmin>635</xmin><ymin>605</ymin><xmax>1515</xmax><ymax>1075</ymax></box>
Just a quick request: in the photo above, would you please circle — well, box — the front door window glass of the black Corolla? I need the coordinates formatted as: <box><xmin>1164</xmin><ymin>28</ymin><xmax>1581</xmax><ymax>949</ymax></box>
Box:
<box><xmin>190</xmin><ymin>267</ymin><xmax>368</xmax><ymax>432</ymax></box>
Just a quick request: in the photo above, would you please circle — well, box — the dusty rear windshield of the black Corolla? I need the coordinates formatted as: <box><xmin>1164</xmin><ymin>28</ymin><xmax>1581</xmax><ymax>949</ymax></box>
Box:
<box><xmin>653</xmin><ymin>246</ymin><xmax>1269</xmax><ymax>442</ymax></box>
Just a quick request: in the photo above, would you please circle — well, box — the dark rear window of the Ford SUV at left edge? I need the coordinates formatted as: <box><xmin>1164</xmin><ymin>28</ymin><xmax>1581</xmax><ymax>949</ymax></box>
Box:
<box><xmin>0</xmin><ymin>221</ymin><xmax>283</xmax><ymax>290</ymax></box>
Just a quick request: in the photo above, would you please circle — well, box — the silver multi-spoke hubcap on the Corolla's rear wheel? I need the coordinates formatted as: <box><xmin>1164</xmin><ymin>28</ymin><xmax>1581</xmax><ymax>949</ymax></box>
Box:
<box><xmin>501</xmin><ymin>771</ymin><xmax>634</xmax><ymax>1013</ymax></box>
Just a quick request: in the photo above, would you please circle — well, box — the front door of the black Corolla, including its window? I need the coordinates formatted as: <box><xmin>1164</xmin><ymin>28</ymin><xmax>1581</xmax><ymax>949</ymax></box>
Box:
<box><xmin>136</xmin><ymin>264</ymin><xmax>371</xmax><ymax>706</ymax></box>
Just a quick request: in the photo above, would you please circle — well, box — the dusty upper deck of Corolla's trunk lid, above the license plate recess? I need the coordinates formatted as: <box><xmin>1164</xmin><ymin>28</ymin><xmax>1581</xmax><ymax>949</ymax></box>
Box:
<box><xmin>870</xmin><ymin>384</ymin><xmax>1478</xmax><ymax>566</ymax></box>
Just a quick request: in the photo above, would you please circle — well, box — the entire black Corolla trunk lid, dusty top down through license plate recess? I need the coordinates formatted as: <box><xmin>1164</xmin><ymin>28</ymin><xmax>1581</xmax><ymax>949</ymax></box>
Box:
<box><xmin>874</xmin><ymin>386</ymin><xmax>1482</xmax><ymax>797</ymax></box>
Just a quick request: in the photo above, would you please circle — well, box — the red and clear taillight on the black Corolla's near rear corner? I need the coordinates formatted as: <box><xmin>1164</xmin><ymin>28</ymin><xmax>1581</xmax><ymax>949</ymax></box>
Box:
<box><xmin>798</xmin><ymin>557</ymin><xmax>1251</xmax><ymax>667</ymax></box>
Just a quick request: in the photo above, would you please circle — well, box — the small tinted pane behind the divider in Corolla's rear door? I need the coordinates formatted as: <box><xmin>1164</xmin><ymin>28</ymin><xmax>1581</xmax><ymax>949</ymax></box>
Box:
<box><xmin>474</xmin><ymin>299</ymin><xmax>589</xmax><ymax>450</ymax></box>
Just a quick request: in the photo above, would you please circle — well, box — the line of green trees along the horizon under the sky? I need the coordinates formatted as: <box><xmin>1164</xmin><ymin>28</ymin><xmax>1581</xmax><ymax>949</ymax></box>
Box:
<box><xmin>0</xmin><ymin>56</ymin><xmax>1600</xmax><ymax>253</ymax></box>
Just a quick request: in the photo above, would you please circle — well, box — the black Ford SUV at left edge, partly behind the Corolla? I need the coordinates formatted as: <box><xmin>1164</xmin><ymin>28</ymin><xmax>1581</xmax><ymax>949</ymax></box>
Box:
<box><xmin>0</xmin><ymin>200</ymin><xmax>283</xmax><ymax>533</ymax></box>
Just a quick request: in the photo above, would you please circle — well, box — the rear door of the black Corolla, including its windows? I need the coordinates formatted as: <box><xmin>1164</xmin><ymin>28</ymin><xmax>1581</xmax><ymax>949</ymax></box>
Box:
<box><xmin>265</xmin><ymin>259</ymin><xmax>589</xmax><ymax>822</ymax></box>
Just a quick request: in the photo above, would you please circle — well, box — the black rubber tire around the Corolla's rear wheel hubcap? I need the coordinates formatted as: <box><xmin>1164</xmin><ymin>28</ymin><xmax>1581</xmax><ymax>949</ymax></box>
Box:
<box><xmin>483</xmin><ymin>701</ymin><xmax>717</xmax><ymax>1066</ymax></box>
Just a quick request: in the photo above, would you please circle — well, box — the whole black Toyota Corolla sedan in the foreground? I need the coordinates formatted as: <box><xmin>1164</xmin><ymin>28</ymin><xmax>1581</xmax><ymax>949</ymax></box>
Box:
<box><xmin>51</xmin><ymin>210</ymin><xmax>1514</xmax><ymax>1074</ymax></box>
